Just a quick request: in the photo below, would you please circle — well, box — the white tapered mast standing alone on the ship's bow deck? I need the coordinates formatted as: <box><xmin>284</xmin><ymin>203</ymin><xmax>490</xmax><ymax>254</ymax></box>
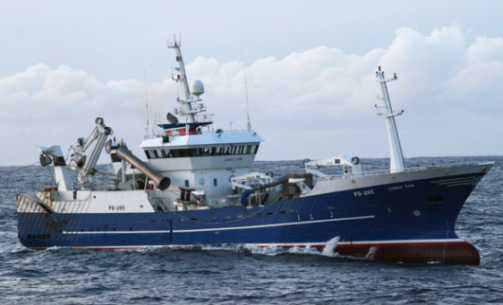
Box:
<box><xmin>376</xmin><ymin>66</ymin><xmax>405</xmax><ymax>173</ymax></box>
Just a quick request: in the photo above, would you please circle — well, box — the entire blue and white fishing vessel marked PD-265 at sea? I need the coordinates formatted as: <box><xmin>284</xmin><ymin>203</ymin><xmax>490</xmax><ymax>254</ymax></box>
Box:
<box><xmin>17</xmin><ymin>40</ymin><xmax>493</xmax><ymax>265</ymax></box>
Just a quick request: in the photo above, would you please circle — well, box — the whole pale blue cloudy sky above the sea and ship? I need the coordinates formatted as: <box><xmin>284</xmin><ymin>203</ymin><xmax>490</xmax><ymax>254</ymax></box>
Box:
<box><xmin>0</xmin><ymin>0</ymin><xmax>503</xmax><ymax>166</ymax></box>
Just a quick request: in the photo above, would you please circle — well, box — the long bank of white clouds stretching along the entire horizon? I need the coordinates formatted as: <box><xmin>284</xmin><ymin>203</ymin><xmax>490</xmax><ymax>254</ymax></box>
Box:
<box><xmin>0</xmin><ymin>26</ymin><xmax>503</xmax><ymax>164</ymax></box>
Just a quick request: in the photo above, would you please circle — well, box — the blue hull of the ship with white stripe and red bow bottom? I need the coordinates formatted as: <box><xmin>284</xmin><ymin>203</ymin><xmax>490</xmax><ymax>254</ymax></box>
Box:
<box><xmin>18</xmin><ymin>174</ymin><xmax>483</xmax><ymax>264</ymax></box>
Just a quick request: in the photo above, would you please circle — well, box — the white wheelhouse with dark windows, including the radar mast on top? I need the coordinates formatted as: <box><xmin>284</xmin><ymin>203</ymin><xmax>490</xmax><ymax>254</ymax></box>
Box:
<box><xmin>125</xmin><ymin>41</ymin><xmax>264</xmax><ymax>207</ymax></box>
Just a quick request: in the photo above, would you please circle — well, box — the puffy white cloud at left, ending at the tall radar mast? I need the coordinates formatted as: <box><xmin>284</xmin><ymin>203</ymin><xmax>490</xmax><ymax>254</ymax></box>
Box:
<box><xmin>0</xmin><ymin>63</ymin><xmax>173</xmax><ymax>124</ymax></box>
